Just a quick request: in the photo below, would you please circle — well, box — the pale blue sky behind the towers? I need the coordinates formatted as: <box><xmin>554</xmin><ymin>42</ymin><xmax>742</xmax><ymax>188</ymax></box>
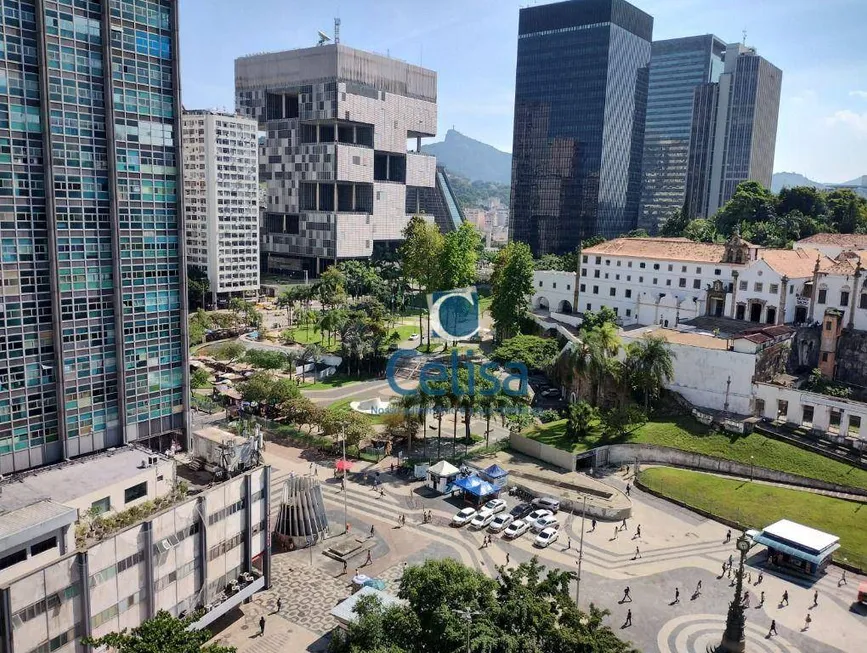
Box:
<box><xmin>180</xmin><ymin>0</ymin><xmax>867</xmax><ymax>182</ymax></box>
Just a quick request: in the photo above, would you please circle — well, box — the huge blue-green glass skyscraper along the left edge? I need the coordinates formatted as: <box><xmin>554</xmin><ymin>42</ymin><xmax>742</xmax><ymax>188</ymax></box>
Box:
<box><xmin>0</xmin><ymin>0</ymin><xmax>188</xmax><ymax>474</ymax></box>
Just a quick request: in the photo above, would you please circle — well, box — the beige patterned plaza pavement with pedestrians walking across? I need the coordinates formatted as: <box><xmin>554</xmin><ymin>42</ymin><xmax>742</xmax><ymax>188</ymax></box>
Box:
<box><xmin>205</xmin><ymin>443</ymin><xmax>867</xmax><ymax>653</ymax></box>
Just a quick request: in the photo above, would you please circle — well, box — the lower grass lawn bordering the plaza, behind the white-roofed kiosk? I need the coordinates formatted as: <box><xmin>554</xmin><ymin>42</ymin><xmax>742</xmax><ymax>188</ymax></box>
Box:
<box><xmin>640</xmin><ymin>467</ymin><xmax>867</xmax><ymax>570</ymax></box>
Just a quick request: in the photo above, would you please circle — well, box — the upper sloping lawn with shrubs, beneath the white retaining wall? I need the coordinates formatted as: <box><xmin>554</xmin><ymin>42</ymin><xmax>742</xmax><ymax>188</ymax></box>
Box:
<box><xmin>526</xmin><ymin>417</ymin><xmax>867</xmax><ymax>489</ymax></box>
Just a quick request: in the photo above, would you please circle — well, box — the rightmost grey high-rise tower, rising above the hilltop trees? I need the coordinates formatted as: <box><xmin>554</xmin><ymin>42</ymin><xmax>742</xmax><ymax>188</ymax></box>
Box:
<box><xmin>685</xmin><ymin>43</ymin><xmax>783</xmax><ymax>217</ymax></box>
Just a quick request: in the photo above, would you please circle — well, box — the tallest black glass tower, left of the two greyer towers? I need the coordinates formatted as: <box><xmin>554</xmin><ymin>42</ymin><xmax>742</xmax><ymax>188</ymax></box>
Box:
<box><xmin>509</xmin><ymin>0</ymin><xmax>653</xmax><ymax>255</ymax></box>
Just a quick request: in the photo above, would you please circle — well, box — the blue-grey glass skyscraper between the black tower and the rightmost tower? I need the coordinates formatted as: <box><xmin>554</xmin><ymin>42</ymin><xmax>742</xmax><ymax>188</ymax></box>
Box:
<box><xmin>638</xmin><ymin>34</ymin><xmax>726</xmax><ymax>233</ymax></box>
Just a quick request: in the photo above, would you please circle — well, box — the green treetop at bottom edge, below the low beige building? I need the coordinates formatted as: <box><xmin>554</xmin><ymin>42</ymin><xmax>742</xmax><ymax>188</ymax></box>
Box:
<box><xmin>82</xmin><ymin>610</ymin><xmax>237</xmax><ymax>653</ymax></box>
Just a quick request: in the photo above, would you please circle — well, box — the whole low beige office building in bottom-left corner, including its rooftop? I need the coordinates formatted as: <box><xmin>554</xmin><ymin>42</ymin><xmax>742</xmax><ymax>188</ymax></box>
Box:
<box><xmin>0</xmin><ymin>447</ymin><xmax>270</xmax><ymax>653</ymax></box>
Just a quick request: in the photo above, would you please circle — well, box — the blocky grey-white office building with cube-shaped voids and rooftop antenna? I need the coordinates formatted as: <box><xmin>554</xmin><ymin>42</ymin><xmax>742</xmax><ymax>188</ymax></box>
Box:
<box><xmin>235</xmin><ymin>44</ymin><xmax>461</xmax><ymax>275</ymax></box>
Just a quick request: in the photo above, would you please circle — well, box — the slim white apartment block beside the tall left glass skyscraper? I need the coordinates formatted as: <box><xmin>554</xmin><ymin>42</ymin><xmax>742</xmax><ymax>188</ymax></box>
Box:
<box><xmin>183</xmin><ymin>111</ymin><xmax>260</xmax><ymax>303</ymax></box>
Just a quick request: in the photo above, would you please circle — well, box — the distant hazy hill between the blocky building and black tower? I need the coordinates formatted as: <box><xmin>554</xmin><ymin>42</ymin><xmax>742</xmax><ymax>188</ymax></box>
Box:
<box><xmin>421</xmin><ymin>129</ymin><xmax>512</xmax><ymax>184</ymax></box>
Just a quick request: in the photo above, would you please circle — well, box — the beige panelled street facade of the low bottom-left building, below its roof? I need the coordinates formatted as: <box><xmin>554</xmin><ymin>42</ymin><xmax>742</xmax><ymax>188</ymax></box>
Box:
<box><xmin>0</xmin><ymin>456</ymin><xmax>270</xmax><ymax>653</ymax></box>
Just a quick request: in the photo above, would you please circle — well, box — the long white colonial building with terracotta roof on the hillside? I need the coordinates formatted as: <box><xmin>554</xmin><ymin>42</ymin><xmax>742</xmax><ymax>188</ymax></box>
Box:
<box><xmin>533</xmin><ymin>235</ymin><xmax>833</xmax><ymax>327</ymax></box>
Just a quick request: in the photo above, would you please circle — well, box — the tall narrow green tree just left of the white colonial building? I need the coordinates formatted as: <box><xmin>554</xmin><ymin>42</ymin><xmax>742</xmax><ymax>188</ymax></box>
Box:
<box><xmin>491</xmin><ymin>241</ymin><xmax>533</xmax><ymax>342</ymax></box>
